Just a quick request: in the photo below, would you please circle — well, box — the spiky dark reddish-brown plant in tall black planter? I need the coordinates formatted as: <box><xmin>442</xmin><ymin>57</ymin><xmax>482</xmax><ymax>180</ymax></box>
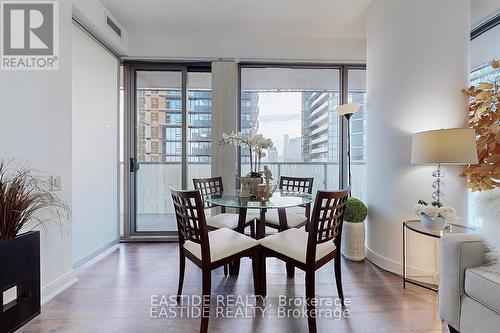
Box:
<box><xmin>0</xmin><ymin>160</ymin><xmax>69</xmax><ymax>332</ymax></box>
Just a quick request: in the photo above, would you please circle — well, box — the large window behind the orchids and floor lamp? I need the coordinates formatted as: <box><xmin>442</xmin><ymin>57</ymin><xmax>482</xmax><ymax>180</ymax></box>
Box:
<box><xmin>240</xmin><ymin>65</ymin><xmax>366</xmax><ymax>199</ymax></box>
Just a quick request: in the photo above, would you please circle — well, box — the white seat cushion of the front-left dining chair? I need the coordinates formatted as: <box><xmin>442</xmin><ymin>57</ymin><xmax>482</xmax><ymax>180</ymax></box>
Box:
<box><xmin>184</xmin><ymin>228</ymin><xmax>259</xmax><ymax>262</ymax></box>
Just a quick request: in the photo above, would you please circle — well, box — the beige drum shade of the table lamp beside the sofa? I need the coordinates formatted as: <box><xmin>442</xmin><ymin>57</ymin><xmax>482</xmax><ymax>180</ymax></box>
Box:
<box><xmin>411</xmin><ymin>128</ymin><xmax>478</xmax><ymax>165</ymax></box>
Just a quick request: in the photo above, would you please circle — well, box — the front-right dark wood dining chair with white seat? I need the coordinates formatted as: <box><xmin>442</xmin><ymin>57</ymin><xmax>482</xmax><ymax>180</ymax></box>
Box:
<box><xmin>260</xmin><ymin>189</ymin><xmax>349</xmax><ymax>332</ymax></box>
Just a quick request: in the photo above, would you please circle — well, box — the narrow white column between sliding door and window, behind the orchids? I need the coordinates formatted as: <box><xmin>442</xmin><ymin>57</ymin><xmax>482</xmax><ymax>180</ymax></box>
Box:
<box><xmin>212</xmin><ymin>61</ymin><xmax>239</xmax><ymax>190</ymax></box>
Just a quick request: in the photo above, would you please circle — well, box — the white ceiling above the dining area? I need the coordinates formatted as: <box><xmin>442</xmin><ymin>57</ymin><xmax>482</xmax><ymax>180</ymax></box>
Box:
<box><xmin>102</xmin><ymin>0</ymin><xmax>372</xmax><ymax>38</ymax></box>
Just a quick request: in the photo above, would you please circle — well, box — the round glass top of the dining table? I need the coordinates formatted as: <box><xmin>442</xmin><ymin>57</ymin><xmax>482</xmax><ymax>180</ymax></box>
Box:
<box><xmin>205</xmin><ymin>191</ymin><xmax>314</xmax><ymax>209</ymax></box>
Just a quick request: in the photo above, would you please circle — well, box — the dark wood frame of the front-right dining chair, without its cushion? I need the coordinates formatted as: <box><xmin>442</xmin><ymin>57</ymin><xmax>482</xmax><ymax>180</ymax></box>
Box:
<box><xmin>258</xmin><ymin>189</ymin><xmax>349</xmax><ymax>332</ymax></box>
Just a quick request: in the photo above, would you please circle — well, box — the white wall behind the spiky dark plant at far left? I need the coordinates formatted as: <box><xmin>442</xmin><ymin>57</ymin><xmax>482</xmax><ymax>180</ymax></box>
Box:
<box><xmin>0</xmin><ymin>1</ymin><xmax>74</xmax><ymax>300</ymax></box>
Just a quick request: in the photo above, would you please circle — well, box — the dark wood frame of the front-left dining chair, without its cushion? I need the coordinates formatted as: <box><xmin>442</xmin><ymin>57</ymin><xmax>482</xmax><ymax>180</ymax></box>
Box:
<box><xmin>170</xmin><ymin>187</ymin><xmax>264</xmax><ymax>333</ymax></box>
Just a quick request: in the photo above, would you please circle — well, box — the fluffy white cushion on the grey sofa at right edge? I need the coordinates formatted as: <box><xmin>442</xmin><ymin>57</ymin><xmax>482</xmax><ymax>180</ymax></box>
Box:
<box><xmin>475</xmin><ymin>188</ymin><xmax>500</xmax><ymax>263</ymax></box>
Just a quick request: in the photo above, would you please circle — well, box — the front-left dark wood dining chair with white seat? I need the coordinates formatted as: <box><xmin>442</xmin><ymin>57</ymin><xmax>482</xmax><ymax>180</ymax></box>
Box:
<box><xmin>169</xmin><ymin>187</ymin><xmax>263</xmax><ymax>332</ymax></box>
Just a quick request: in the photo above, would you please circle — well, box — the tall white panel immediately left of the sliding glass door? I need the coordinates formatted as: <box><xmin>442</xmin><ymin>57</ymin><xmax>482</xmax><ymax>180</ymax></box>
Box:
<box><xmin>72</xmin><ymin>26</ymin><xmax>119</xmax><ymax>264</ymax></box>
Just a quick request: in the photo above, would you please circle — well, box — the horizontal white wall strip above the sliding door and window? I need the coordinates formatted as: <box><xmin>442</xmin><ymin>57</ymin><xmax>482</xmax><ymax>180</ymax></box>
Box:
<box><xmin>127</xmin><ymin>33</ymin><xmax>366</xmax><ymax>62</ymax></box>
